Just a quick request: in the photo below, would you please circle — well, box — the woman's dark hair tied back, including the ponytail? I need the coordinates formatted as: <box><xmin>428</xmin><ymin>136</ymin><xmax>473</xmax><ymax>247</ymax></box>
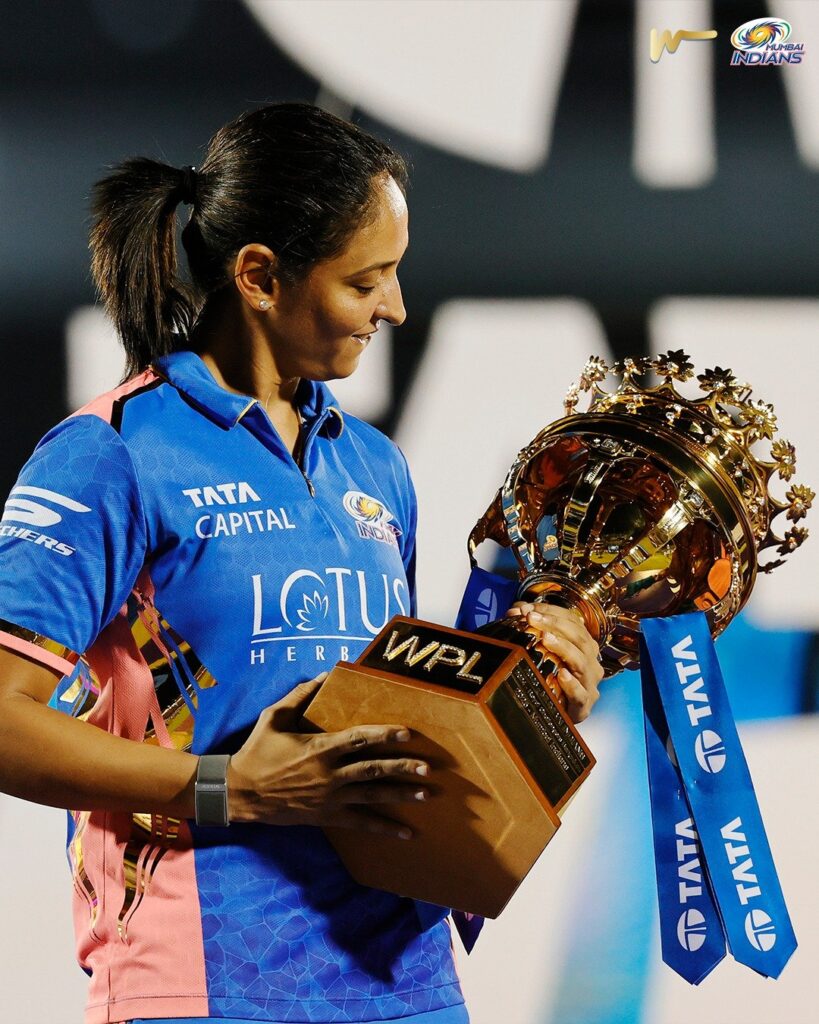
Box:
<box><xmin>89</xmin><ymin>103</ymin><xmax>407</xmax><ymax>376</ymax></box>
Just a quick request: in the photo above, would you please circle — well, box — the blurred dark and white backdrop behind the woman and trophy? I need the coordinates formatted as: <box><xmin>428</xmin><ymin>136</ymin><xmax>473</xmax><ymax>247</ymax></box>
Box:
<box><xmin>0</xmin><ymin>0</ymin><xmax>819</xmax><ymax>1024</ymax></box>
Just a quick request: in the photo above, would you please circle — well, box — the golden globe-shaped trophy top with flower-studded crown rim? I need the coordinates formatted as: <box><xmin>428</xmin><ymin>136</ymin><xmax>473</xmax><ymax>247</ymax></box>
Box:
<box><xmin>469</xmin><ymin>349</ymin><xmax>816</xmax><ymax>674</ymax></box>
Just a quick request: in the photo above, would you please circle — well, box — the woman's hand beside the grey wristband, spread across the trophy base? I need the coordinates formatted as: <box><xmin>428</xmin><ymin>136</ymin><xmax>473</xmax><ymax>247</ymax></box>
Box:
<box><xmin>227</xmin><ymin>673</ymin><xmax>429</xmax><ymax>839</ymax></box>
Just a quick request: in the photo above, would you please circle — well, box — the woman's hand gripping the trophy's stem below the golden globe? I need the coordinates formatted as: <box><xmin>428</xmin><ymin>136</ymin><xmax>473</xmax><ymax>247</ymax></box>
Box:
<box><xmin>506</xmin><ymin>601</ymin><xmax>604</xmax><ymax>722</ymax></box>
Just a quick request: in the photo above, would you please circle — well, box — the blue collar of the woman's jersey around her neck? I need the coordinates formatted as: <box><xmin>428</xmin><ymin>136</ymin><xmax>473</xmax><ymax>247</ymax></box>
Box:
<box><xmin>153</xmin><ymin>350</ymin><xmax>343</xmax><ymax>437</ymax></box>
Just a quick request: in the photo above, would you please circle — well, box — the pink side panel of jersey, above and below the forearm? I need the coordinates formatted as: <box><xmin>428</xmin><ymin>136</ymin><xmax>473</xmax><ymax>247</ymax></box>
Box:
<box><xmin>72</xmin><ymin>589</ymin><xmax>208</xmax><ymax>1024</ymax></box>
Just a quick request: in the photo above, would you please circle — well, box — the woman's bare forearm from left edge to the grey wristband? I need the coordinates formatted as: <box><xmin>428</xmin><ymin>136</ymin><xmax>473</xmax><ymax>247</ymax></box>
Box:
<box><xmin>0</xmin><ymin>694</ymin><xmax>199</xmax><ymax>818</ymax></box>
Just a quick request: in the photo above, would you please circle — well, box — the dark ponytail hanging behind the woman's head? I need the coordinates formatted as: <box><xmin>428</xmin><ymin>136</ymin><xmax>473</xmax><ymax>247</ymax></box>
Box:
<box><xmin>89</xmin><ymin>157</ymin><xmax>202</xmax><ymax>379</ymax></box>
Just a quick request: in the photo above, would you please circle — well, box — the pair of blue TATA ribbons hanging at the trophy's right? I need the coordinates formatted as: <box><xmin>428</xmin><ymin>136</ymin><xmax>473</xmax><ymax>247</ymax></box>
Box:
<box><xmin>640</xmin><ymin>611</ymin><xmax>796</xmax><ymax>984</ymax></box>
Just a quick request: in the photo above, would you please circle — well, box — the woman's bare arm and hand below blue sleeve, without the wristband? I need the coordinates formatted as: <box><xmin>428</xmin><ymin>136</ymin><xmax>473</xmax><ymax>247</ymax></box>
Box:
<box><xmin>0</xmin><ymin>648</ymin><xmax>428</xmax><ymax>839</ymax></box>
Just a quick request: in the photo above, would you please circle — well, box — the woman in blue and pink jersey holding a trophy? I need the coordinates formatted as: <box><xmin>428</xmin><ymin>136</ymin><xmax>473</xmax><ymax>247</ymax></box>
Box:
<box><xmin>0</xmin><ymin>103</ymin><xmax>601</xmax><ymax>1024</ymax></box>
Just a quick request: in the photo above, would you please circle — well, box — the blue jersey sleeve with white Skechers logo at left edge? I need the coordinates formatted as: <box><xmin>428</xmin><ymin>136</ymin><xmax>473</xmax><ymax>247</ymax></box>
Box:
<box><xmin>0</xmin><ymin>415</ymin><xmax>146</xmax><ymax>654</ymax></box>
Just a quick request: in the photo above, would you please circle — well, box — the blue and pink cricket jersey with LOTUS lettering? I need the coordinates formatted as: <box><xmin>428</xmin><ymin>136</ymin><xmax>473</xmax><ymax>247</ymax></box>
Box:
<box><xmin>0</xmin><ymin>351</ymin><xmax>463</xmax><ymax>1024</ymax></box>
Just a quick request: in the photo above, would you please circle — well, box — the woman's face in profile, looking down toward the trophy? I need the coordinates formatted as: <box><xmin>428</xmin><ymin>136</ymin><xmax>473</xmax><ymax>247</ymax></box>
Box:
<box><xmin>269</xmin><ymin>177</ymin><xmax>408</xmax><ymax>380</ymax></box>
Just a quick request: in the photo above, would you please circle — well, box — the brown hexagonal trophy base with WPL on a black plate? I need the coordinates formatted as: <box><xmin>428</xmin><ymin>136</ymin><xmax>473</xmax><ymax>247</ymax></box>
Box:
<box><xmin>305</xmin><ymin>616</ymin><xmax>595</xmax><ymax>918</ymax></box>
